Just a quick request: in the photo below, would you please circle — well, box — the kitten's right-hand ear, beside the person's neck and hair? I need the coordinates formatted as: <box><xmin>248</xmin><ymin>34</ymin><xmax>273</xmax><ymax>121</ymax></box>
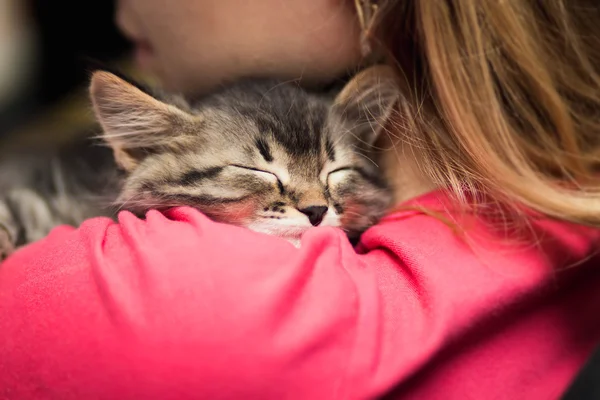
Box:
<box><xmin>333</xmin><ymin>65</ymin><xmax>400</xmax><ymax>146</ymax></box>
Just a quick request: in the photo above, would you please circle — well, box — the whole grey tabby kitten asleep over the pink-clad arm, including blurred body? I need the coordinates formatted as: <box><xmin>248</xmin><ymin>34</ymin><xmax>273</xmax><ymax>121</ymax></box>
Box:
<box><xmin>0</xmin><ymin>67</ymin><xmax>398</xmax><ymax>256</ymax></box>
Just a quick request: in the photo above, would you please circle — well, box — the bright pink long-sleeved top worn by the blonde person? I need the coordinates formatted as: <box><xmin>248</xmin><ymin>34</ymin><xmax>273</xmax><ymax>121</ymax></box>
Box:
<box><xmin>0</xmin><ymin>193</ymin><xmax>600</xmax><ymax>400</ymax></box>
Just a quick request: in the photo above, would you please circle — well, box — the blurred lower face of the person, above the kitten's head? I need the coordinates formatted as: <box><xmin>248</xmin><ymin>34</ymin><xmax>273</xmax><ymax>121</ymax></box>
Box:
<box><xmin>117</xmin><ymin>0</ymin><xmax>361</xmax><ymax>93</ymax></box>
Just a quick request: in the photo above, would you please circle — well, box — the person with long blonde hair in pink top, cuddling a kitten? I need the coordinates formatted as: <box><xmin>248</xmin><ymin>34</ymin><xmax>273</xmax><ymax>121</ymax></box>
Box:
<box><xmin>0</xmin><ymin>0</ymin><xmax>600</xmax><ymax>400</ymax></box>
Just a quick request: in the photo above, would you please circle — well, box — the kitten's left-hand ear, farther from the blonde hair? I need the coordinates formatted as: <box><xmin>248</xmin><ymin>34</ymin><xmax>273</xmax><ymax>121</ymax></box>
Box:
<box><xmin>90</xmin><ymin>71</ymin><xmax>194</xmax><ymax>171</ymax></box>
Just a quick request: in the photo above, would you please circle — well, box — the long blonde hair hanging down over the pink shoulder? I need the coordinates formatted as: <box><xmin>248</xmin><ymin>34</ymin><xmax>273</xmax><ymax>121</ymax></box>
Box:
<box><xmin>374</xmin><ymin>0</ymin><xmax>600</xmax><ymax>226</ymax></box>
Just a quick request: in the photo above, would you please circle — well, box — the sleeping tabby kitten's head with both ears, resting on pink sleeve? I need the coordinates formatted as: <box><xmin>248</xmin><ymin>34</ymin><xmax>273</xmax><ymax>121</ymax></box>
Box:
<box><xmin>90</xmin><ymin>67</ymin><xmax>398</xmax><ymax>240</ymax></box>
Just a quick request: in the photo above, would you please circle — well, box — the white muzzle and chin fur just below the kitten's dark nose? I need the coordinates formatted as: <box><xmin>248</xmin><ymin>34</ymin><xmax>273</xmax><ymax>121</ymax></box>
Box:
<box><xmin>246</xmin><ymin>210</ymin><xmax>340</xmax><ymax>247</ymax></box>
